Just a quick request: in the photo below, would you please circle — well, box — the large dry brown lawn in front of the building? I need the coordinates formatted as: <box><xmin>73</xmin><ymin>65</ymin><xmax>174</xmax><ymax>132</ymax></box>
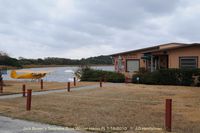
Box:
<box><xmin>0</xmin><ymin>84</ymin><xmax>200</xmax><ymax>133</ymax></box>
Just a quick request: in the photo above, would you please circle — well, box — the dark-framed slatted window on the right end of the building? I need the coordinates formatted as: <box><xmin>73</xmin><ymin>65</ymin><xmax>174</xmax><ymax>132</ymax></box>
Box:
<box><xmin>180</xmin><ymin>57</ymin><xmax>198</xmax><ymax>68</ymax></box>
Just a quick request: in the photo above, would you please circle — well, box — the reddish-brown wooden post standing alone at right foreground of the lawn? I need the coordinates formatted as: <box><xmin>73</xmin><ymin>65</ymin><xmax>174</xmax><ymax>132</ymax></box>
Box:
<box><xmin>165</xmin><ymin>99</ymin><xmax>172</xmax><ymax>132</ymax></box>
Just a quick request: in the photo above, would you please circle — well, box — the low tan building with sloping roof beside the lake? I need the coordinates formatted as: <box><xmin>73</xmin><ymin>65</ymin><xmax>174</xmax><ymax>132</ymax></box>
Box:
<box><xmin>111</xmin><ymin>43</ymin><xmax>200</xmax><ymax>77</ymax></box>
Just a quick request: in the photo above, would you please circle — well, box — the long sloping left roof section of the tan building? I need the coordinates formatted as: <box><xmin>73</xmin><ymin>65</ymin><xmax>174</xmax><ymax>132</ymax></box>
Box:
<box><xmin>110</xmin><ymin>43</ymin><xmax>189</xmax><ymax>56</ymax></box>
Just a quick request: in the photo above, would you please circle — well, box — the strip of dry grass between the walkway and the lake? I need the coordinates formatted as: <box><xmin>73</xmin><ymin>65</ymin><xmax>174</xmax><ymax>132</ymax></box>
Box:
<box><xmin>0</xmin><ymin>81</ymin><xmax>98</xmax><ymax>95</ymax></box>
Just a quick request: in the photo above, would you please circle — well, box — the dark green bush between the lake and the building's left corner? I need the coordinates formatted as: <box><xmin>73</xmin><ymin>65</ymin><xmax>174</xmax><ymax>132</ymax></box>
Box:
<box><xmin>81</xmin><ymin>68</ymin><xmax>125</xmax><ymax>83</ymax></box>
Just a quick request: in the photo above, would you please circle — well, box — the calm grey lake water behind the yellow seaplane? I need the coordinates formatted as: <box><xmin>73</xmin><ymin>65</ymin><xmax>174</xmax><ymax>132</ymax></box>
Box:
<box><xmin>3</xmin><ymin>66</ymin><xmax>114</xmax><ymax>82</ymax></box>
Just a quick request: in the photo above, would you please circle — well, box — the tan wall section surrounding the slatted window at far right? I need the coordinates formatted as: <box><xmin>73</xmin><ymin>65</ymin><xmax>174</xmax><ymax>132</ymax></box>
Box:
<box><xmin>168</xmin><ymin>46</ymin><xmax>200</xmax><ymax>68</ymax></box>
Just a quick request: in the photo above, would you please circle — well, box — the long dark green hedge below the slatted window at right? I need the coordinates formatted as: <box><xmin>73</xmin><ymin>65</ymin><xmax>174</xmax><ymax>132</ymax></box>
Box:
<box><xmin>132</xmin><ymin>69</ymin><xmax>200</xmax><ymax>86</ymax></box>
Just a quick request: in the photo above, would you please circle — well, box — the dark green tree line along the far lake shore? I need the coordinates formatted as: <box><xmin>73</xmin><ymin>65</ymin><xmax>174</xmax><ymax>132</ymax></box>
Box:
<box><xmin>0</xmin><ymin>53</ymin><xmax>113</xmax><ymax>67</ymax></box>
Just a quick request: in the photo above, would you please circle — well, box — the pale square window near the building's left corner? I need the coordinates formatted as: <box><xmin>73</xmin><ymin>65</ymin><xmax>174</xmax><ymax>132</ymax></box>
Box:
<box><xmin>126</xmin><ymin>60</ymin><xmax>140</xmax><ymax>72</ymax></box>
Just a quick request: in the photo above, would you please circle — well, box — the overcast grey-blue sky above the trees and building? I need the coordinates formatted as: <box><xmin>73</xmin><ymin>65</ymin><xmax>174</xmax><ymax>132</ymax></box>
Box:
<box><xmin>0</xmin><ymin>0</ymin><xmax>200</xmax><ymax>59</ymax></box>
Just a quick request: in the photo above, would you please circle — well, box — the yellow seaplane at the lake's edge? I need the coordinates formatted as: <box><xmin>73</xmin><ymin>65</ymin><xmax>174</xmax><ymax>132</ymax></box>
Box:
<box><xmin>10</xmin><ymin>70</ymin><xmax>49</xmax><ymax>79</ymax></box>
